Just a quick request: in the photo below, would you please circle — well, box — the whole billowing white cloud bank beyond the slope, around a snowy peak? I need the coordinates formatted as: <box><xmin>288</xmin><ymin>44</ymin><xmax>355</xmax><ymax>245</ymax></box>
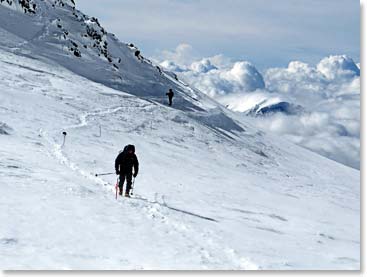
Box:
<box><xmin>156</xmin><ymin>44</ymin><xmax>360</xmax><ymax>169</ymax></box>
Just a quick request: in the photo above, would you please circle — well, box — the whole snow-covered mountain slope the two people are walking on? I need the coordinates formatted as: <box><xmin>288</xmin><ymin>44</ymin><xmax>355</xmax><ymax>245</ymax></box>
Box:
<box><xmin>0</xmin><ymin>1</ymin><xmax>360</xmax><ymax>269</ymax></box>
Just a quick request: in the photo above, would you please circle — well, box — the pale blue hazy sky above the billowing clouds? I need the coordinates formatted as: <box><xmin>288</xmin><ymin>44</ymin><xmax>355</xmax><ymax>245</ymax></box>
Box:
<box><xmin>76</xmin><ymin>0</ymin><xmax>360</xmax><ymax>69</ymax></box>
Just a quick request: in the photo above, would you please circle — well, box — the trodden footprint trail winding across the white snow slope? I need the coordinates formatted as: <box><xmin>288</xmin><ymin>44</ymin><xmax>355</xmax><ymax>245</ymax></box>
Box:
<box><xmin>36</xmin><ymin>94</ymin><xmax>258</xmax><ymax>269</ymax></box>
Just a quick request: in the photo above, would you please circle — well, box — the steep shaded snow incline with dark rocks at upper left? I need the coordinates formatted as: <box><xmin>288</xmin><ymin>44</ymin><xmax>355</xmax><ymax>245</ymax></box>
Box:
<box><xmin>0</xmin><ymin>0</ymin><xmax>215</xmax><ymax>110</ymax></box>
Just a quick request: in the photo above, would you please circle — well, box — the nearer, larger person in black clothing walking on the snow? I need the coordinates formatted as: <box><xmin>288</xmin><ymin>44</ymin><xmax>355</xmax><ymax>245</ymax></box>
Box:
<box><xmin>115</xmin><ymin>145</ymin><xmax>139</xmax><ymax>197</ymax></box>
